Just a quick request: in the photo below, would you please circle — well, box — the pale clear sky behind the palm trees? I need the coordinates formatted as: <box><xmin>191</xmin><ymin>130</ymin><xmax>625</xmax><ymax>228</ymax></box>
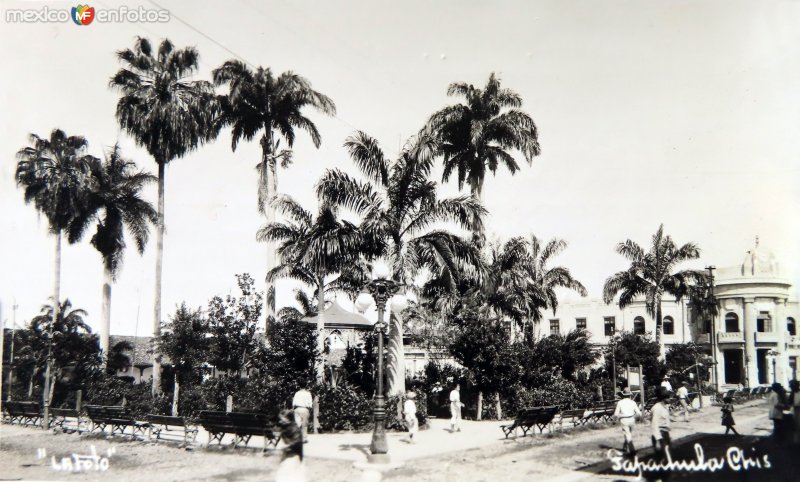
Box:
<box><xmin>0</xmin><ymin>0</ymin><xmax>800</xmax><ymax>335</ymax></box>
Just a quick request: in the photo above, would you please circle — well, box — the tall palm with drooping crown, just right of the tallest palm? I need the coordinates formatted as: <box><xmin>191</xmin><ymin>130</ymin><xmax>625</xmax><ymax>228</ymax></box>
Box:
<box><xmin>212</xmin><ymin>60</ymin><xmax>336</xmax><ymax>324</ymax></box>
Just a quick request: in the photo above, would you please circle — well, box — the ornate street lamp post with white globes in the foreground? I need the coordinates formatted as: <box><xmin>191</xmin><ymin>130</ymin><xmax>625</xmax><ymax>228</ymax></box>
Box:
<box><xmin>356</xmin><ymin>265</ymin><xmax>400</xmax><ymax>464</ymax></box>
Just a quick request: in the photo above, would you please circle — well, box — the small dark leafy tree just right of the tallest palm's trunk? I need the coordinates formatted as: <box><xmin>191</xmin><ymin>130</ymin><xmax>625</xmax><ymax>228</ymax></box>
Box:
<box><xmin>158</xmin><ymin>303</ymin><xmax>211</xmax><ymax>416</ymax></box>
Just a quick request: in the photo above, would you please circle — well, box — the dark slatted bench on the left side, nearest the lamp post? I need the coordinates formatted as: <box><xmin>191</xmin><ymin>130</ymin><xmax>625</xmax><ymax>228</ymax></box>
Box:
<box><xmin>197</xmin><ymin>410</ymin><xmax>280</xmax><ymax>452</ymax></box>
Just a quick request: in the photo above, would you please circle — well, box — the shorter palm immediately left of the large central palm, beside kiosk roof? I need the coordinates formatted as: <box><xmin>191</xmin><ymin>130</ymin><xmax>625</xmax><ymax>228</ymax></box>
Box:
<box><xmin>256</xmin><ymin>196</ymin><xmax>361</xmax><ymax>381</ymax></box>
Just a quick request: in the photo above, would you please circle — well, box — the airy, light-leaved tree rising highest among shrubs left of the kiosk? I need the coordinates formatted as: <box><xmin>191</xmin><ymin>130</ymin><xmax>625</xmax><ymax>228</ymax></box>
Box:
<box><xmin>208</xmin><ymin>273</ymin><xmax>264</xmax><ymax>376</ymax></box>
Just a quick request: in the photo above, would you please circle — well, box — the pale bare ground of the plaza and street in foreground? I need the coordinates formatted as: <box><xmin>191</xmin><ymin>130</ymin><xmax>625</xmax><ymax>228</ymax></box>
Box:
<box><xmin>0</xmin><ymin>401</ymin><xmax>788</xmax><ymax>482</ymax></box>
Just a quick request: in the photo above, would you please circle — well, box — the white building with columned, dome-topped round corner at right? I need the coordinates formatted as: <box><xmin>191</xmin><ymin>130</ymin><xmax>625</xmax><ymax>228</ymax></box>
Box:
<box><xmin>540</xmin><ymin>240</ymin><xmax>800</xmax><ymax>389</ymax></box>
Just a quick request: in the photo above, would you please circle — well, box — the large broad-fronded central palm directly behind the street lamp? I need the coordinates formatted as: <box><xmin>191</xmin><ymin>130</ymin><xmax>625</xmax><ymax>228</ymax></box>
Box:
<box><xmin>317</xmin><ymin>132</ymin><xmax>486</xmax><ymax>394</ymax></box>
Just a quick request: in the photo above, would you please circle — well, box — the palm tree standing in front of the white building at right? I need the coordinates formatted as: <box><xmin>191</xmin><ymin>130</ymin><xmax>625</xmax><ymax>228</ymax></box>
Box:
<box><xmin>603</xmin><ymin>224</ymin><xmax>705</xmax><ymax>360</ymax></box>
